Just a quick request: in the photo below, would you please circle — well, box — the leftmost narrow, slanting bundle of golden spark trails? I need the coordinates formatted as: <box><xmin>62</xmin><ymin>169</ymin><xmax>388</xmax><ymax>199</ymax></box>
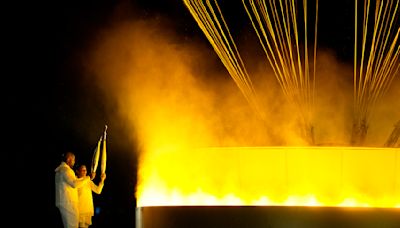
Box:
<box><xmin>183</xmin><ymin>0</ymin><xmax>264</xmax><ymax>119</ymax></box>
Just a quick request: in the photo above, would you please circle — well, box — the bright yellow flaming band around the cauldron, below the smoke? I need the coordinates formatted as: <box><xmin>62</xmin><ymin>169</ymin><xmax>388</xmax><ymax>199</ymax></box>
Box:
<box><xmin>137</xmin><ymin>147</ymin><xmax>400</xmax><ymax>208</ymax></box>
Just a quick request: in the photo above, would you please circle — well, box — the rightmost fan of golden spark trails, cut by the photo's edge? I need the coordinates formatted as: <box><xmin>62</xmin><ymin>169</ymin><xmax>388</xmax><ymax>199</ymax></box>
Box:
<box><xmin>351</xmin><ymin>0</ymin><xmax>400</xmax><ymax>145</ymax></box>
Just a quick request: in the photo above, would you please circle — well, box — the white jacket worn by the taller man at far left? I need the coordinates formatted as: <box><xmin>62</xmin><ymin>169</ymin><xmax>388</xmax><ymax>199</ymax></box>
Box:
<box><xmin>55</xmin><ymin>162</ymin><xmax>90</xmax><ymax>213</ymax></box>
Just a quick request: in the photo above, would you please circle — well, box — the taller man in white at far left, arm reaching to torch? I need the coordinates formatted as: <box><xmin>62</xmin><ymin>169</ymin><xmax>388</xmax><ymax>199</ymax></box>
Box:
<box><xmin>55</xmin><ymin>152</ymin><xmax>91</xmax><ymax>228</ymax></box>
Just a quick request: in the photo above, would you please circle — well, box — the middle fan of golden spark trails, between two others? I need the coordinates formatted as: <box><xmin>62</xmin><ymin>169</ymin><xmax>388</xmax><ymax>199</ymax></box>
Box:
<box><xmin>242</xmin><ymin>0</ymin><xmax>318</xmax><ymax>143</ymax></box>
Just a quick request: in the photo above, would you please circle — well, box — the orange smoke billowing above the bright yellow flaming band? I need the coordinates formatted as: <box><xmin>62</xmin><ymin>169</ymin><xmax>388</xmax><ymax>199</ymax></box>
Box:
<box><xmin>83</xmin><ymin>9</ymin><xmax>400</xmax><ymax>151</ymax></box>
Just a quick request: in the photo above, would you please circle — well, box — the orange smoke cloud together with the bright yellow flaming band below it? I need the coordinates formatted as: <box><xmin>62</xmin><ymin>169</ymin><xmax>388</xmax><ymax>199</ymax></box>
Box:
<box><xmin>82</xmin><ymin>4</ymin><xmax>400</xmax><ymax>210</ymax></box>
